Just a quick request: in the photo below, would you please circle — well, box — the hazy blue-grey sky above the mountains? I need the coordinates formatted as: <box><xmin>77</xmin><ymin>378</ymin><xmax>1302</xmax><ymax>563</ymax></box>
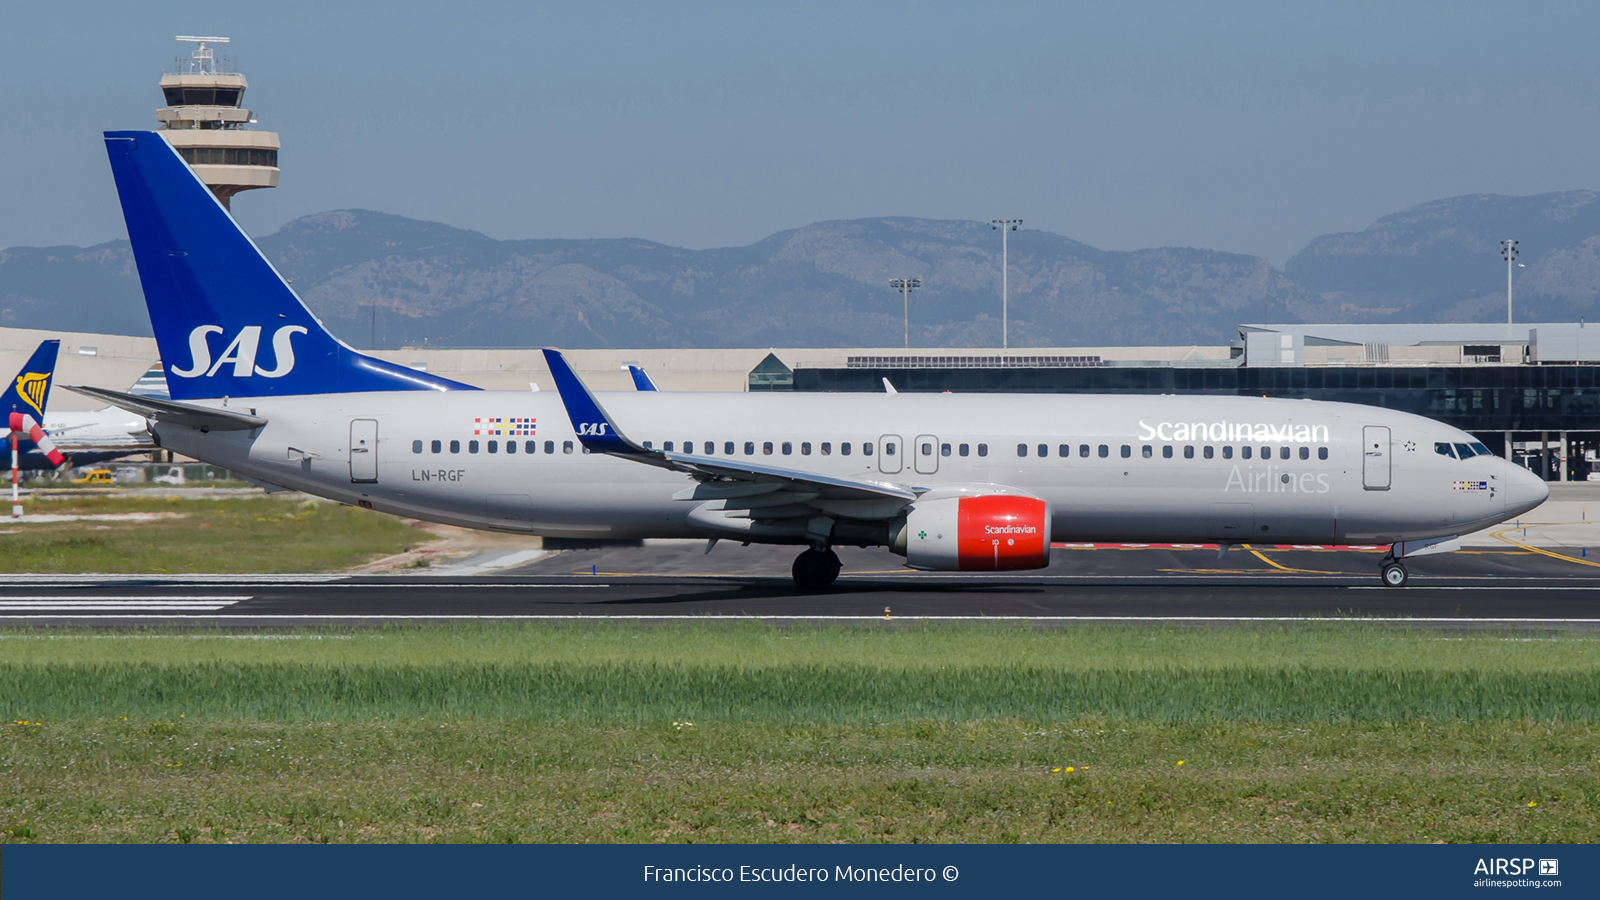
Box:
<box><xmin>0</xmin><ymin>0</ymin><xmax>1600</xmax><ymax>266</ymax></box>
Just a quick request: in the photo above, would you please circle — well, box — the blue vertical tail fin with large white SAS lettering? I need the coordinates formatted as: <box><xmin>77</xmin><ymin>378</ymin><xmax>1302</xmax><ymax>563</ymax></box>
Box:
<box><xmin>106</xmin><ymin>131</ymin><xmax>475</xmax><ymax>400</ymax></box>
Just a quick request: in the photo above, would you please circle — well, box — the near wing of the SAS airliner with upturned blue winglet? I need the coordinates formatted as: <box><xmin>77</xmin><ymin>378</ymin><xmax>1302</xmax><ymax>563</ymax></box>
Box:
<box><xmin>544</xmin><ymin>349</ymin><xmax>917</xmax><ymax>512</ymax></box>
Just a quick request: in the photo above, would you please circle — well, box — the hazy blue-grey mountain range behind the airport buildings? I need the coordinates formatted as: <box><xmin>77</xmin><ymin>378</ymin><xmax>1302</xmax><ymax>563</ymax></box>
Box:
<box><xmin>0</xmin><ymin>191</ymin><xmax>1600</xmax><ymax>349</ymax></box>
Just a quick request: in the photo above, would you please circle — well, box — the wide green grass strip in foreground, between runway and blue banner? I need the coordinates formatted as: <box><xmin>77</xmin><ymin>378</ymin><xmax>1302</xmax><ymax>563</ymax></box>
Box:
<box><xmin>0</xmin><ymin>623</ymin><xmax>1600</xmax><ymax>841</ymax></box>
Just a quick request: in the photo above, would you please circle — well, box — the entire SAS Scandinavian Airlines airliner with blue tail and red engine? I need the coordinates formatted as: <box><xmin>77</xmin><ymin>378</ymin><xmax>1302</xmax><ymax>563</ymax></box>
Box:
<box><xmin>74</xmin><ymin>131</ymin><xmax>1549</xmax><ymax>589</ymax></box>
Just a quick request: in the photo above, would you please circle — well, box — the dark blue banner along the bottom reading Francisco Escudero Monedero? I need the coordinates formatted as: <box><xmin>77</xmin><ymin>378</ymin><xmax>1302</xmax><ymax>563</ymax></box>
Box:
<box><xmin>0</xmin><ymin>844</ymin><xmax>1600</xmax><ymax>900</ymax></box>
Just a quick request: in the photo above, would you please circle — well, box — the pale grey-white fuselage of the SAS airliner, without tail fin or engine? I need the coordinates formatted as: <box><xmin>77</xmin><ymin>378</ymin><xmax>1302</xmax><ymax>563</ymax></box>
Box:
<box><xmin>157</xmin><ymin>391</ymin><xmax>1549</xmax><ymax>543</ymax></box>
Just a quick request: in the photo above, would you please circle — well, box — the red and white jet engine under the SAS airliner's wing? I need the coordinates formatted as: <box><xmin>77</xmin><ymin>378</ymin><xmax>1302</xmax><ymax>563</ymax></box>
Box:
<box><xmin>904</xmin><ymin>495</ymin><xmax>1050</xmax><ymax>572</ymax></box>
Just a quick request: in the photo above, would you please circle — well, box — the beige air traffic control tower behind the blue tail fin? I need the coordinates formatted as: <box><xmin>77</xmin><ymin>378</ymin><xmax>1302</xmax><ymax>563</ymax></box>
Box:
<box><xmin>155</xmin><ymin>35</ymin><xmax>278</xmax><ymax>207</ymax></box>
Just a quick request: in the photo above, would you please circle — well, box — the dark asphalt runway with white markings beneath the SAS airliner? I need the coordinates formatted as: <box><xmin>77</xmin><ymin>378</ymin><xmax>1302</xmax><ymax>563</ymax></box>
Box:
<box><xmin>0</xmin><ymin>543</ymin><xmax>1600</xmax><ymax>628</ymax></box>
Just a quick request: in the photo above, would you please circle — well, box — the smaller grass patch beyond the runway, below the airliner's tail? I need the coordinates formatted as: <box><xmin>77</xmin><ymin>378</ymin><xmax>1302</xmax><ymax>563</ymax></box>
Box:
<box><xmin>0</xmin><ymin>490</ymin><xmax>432</xmax><ymax>573</ymax></box>
